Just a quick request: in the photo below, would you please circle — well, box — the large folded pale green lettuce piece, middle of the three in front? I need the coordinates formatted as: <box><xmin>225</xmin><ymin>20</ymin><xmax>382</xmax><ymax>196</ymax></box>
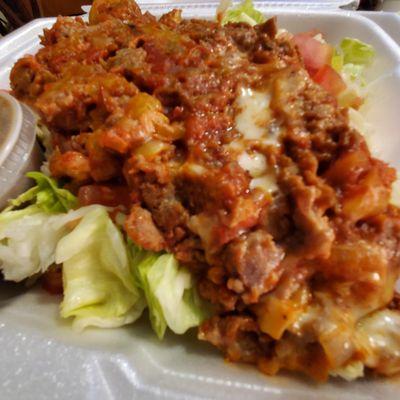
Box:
<box><xmin>56</xmin><ymin>206</ymin><xmax>145</xmax><ymax>330</ymax></box>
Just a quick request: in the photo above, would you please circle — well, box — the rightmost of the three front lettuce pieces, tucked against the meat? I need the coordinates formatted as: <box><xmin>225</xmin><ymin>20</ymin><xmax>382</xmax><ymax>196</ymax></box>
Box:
<box><xmin>130</xmin><ymin>243</ymin><xmax>208</xmax><ymax>339</ymax></box>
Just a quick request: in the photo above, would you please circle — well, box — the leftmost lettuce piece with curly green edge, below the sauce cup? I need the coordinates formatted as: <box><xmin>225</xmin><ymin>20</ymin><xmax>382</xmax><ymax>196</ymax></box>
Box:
<box><xmin>0</xmin><ymin>172</ymin><xmax>79</xmax><ymax>282</ymax></box>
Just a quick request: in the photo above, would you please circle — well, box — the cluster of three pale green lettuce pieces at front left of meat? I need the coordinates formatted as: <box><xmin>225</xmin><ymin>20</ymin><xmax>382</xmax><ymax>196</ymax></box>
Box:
<box><xmin>0</xmin><ymin>172</ymin><xmax>207</xmax><ymax>338</ymax></box>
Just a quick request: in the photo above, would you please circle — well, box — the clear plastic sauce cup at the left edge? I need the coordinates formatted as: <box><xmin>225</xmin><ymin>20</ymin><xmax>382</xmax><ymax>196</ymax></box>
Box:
<box><xmin>0</xmin><ymin>91</ymin><xmax>42</xmax><ymax>209</ymax></box>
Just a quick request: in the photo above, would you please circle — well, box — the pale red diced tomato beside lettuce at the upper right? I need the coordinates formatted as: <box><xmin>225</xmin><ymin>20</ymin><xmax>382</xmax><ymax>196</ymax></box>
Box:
<box><xmin>294</xmin><ymin>32</ymin><xmax>333</xmax><ymax>76</ymax></box>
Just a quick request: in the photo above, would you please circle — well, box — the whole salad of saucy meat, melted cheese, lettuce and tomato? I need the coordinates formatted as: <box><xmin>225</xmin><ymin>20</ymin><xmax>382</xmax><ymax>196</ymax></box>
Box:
<box><xmin>0</xmin><ymin>0</ymin><xmax>400</xmax><ymax>381</ymax></box>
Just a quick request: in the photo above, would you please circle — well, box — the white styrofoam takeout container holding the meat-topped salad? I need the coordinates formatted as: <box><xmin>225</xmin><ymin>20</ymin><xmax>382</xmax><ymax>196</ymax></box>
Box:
<box><xmin>0</xmin><ymin>6</ymin><xmax>400</xmax><ymax>400</ymax></box>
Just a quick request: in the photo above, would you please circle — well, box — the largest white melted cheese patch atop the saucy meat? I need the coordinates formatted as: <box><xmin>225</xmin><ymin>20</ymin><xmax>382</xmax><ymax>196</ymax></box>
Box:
<box><xmin>235</xmin><ymin>88</ymin><xmax>271</xmax><ymax>140</ymax></box>
